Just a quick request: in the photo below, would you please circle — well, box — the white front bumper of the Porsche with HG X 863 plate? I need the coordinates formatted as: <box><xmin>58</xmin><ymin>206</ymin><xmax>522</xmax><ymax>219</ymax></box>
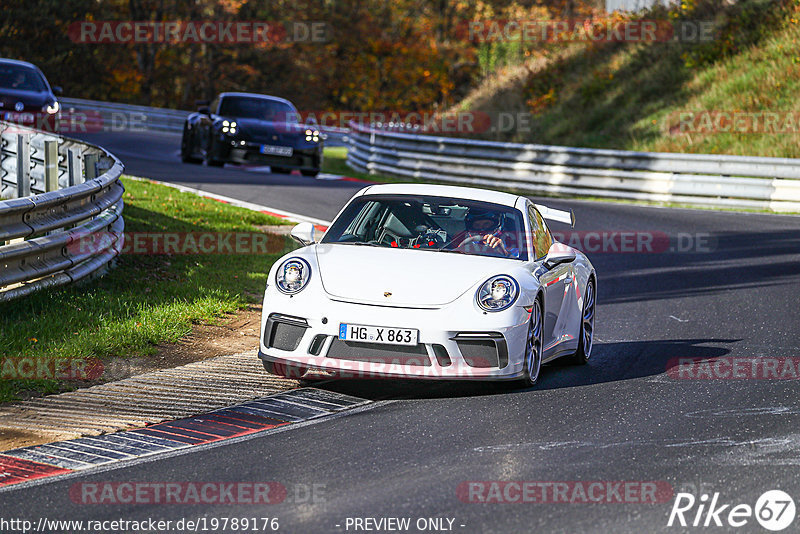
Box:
<box><xmin>259</xmin><ymin>287</ymin><xmax>529</xmax><ymax>380</ymax></box>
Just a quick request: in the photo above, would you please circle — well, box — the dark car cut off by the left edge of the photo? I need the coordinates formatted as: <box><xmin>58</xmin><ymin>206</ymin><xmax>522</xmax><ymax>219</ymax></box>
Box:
<box><xmin>0</xmin><ymin>58</ymin><xmax>61</xmax><ymax>128</ymax></box>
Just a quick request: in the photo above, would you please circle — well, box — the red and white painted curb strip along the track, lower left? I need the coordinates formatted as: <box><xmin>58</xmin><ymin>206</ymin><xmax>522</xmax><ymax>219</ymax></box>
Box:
<box><xmin>0</xmin><ymin>388</ymin><xmax>370</xmax><ymax>488</ymax></box>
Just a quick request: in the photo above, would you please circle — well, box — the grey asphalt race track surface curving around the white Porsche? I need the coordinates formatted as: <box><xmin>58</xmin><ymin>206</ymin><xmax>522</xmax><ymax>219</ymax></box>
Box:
<box><xmin>0</xmin><ymin>129</ymin><xmax>800</xmax><ymax>533</ymax></box>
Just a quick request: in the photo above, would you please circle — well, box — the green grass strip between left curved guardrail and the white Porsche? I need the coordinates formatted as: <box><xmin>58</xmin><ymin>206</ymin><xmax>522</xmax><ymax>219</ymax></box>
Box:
<box><xmin>0</xmin><ymin>179</ymin><xmax>289</xmax><ymax>402</ymax></box>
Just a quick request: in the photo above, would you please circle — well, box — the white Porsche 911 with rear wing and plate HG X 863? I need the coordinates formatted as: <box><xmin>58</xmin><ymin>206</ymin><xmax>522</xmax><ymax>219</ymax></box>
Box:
<box><xmin>259</xmin><ymin>184</ymin><xmax>597</xmax><ymax>384</ymax></box>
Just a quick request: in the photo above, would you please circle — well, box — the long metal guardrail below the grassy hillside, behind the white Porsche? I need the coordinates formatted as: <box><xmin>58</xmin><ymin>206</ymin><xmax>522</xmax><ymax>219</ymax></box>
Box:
<box><xmin>347</xmin><ymin>123</ymin><xmax>800</xmax><ymax>212</ymax></box>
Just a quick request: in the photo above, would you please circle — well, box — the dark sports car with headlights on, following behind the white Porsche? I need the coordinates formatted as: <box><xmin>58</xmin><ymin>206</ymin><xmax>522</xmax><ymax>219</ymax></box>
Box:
<box><xmin>181</xmin><ymin>93</ymin><xmax>322</xmax><ymax>176</ymax></box>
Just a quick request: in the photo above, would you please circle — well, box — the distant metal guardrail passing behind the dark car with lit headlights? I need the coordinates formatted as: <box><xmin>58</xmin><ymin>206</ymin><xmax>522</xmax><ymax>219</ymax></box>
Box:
<box><xmin>59</xmin><ymin>98</ymin><xmax>348</xmax><ymax>146</ymax></box>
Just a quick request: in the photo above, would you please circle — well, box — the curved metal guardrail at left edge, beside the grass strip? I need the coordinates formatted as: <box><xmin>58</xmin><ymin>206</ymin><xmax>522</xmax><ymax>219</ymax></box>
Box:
<box><xmin>0</xmin><ymin>121</ymin><xmax>124</xmax><ymax>302</ymax></box>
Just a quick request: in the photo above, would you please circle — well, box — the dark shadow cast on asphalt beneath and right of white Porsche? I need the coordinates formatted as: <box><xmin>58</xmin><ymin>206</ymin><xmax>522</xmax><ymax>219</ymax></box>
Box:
<box><xmin>308</xmin><ymin>339</ymin><xmax>740</xmax><ymax>400</ymax></box>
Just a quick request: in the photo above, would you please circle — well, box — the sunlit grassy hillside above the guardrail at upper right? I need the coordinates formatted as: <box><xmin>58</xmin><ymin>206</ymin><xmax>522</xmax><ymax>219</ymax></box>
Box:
<box><xmin>461</xmin><ymin>0</ymin><xmax>800</xmax><ymax>158</ymax></box>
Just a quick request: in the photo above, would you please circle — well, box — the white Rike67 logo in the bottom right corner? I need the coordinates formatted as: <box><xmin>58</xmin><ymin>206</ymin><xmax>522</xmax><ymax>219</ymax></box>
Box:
<box><xmin>667</xmin><ymin>490</ymin><xmax>796</xmax><ymax>532</ymax></box>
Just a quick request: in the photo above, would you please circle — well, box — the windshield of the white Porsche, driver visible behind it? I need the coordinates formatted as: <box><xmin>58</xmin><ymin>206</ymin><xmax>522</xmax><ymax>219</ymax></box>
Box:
<box><xmin>322</xmin><ymin>195</ymin><xmax>528</xmax><ymax>260</ymax></box>
